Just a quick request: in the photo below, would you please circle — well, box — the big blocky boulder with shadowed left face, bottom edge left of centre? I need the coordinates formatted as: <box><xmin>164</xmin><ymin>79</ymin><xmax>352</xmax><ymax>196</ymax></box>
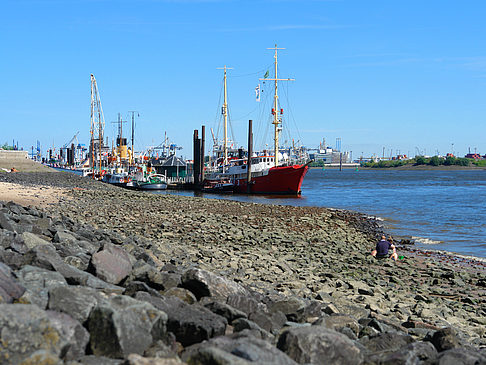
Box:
<box><xmin>88</xmin><ymin>295</ymin><xmax>167</xmax><ymax>358</ymax></box>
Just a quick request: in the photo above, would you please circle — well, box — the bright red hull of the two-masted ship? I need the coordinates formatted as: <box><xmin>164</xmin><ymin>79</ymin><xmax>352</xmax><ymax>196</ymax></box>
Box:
<box><xmin>234</xmin><ymin>164</ymin><xmax>309</xmax><ymax>195</ymax></box>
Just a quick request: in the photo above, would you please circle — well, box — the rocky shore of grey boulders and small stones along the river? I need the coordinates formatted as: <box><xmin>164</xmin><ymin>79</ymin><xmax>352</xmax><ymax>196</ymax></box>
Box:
<box><xmin>0</xmin><ymin>173</ymin><xmax>486</xmax><ymax>365</ymax></box>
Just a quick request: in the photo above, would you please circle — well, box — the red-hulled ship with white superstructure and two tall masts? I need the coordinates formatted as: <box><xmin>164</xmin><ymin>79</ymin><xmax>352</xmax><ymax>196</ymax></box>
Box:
<box><xmin>204</xmin><ymin>45</ymin><xmax>310</xmax><ymax>195</ymax></box>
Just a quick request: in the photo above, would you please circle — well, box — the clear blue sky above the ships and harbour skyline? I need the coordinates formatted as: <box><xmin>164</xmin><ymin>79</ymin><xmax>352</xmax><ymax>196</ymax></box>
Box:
<box><xmin>0</xmin><ymin>0</ymin><xmax>486</xmax><ymax>157</ymax></box>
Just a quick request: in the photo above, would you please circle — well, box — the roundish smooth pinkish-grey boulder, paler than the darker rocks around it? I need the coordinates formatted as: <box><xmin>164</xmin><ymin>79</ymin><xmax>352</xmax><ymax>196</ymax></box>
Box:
<box><xmin>91</xmin><ymin>243</ymin><xmax>132</xmax><ymax>284</ymax></box>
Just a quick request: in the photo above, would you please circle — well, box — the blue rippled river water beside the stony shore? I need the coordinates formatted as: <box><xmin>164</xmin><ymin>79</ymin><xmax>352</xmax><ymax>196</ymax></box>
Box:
<box><xmin>157</xmin><ymin>169</ymin><xmax>486</xmax><ymax>258</ymax></box>
